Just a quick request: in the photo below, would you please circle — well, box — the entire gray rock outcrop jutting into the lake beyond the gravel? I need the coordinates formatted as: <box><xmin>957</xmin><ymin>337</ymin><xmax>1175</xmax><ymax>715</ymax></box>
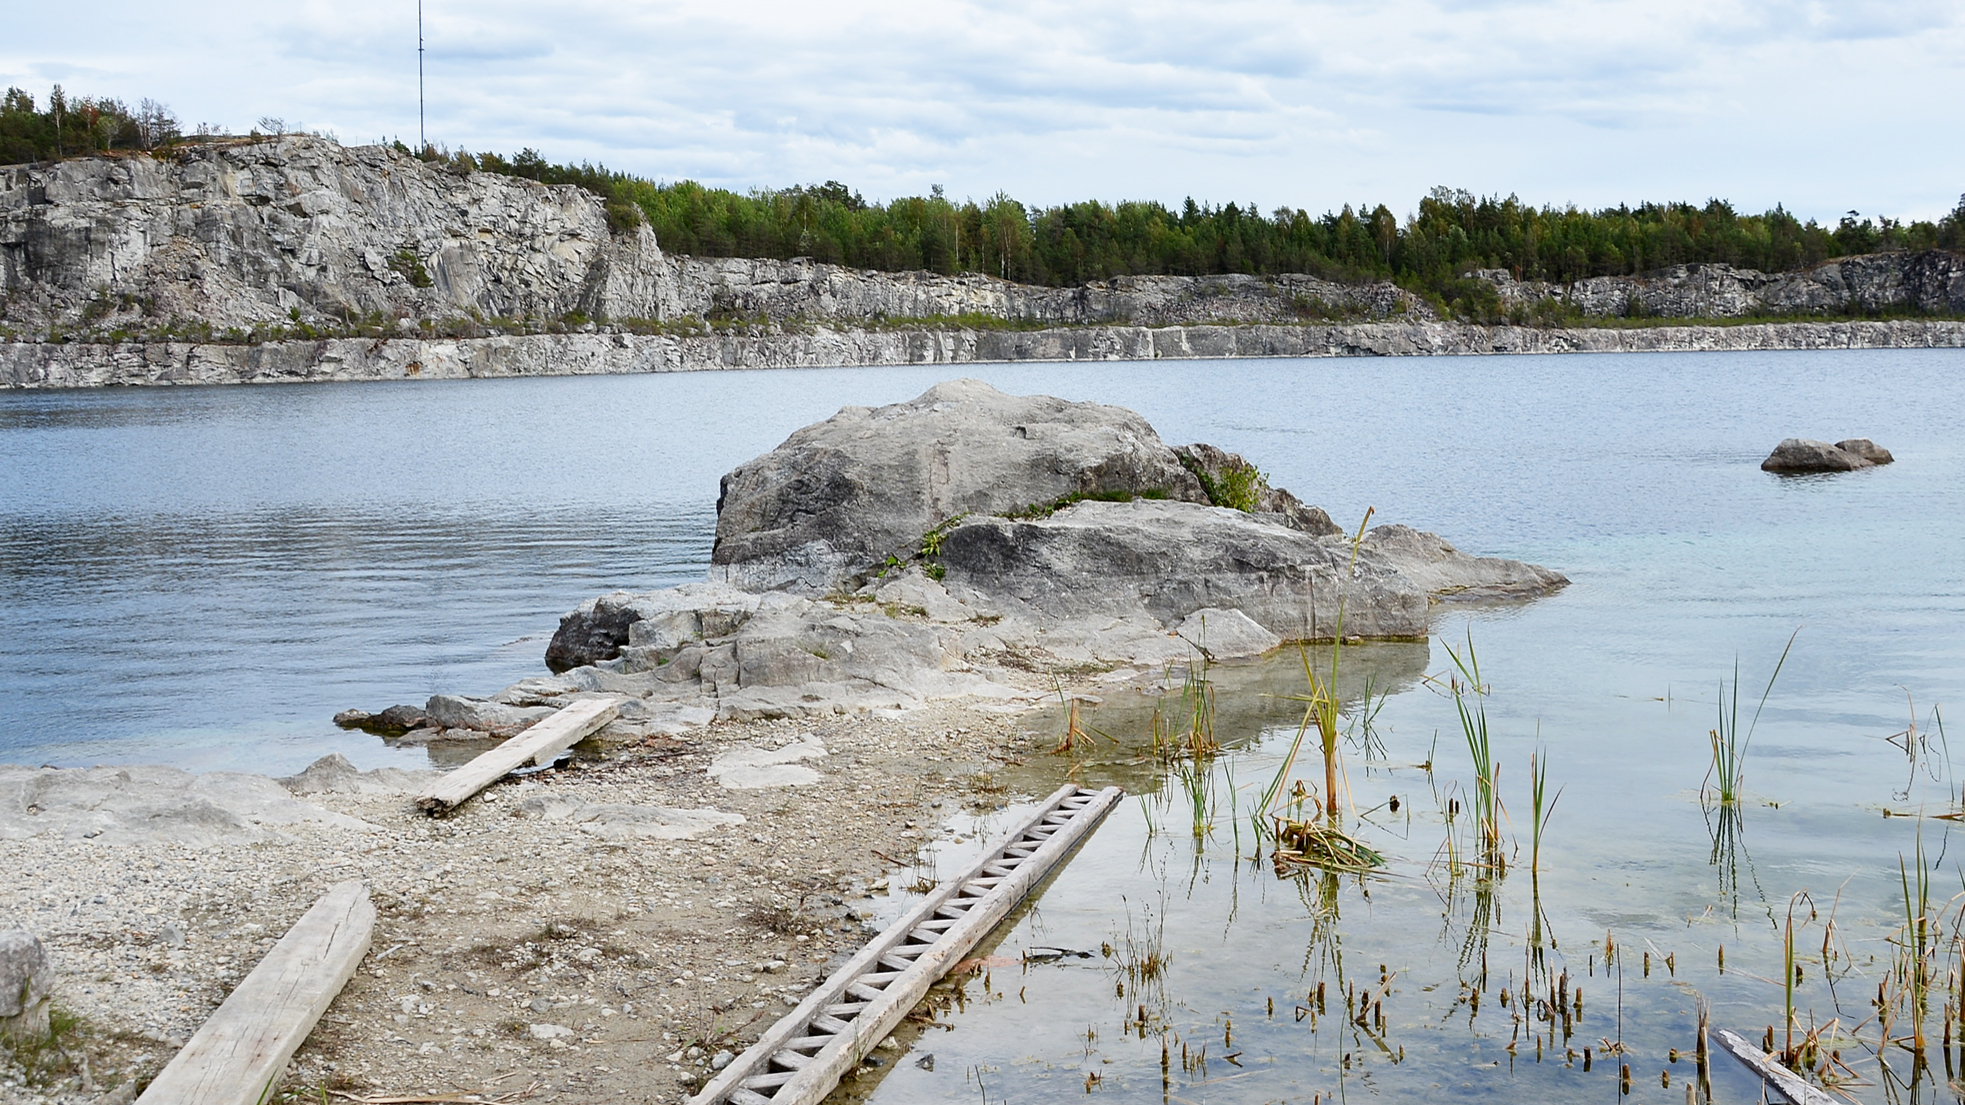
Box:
<box><xmin>530</xmin><ymin>381</ymin><xmax>1566</xmax><ymax>724</ymax></box>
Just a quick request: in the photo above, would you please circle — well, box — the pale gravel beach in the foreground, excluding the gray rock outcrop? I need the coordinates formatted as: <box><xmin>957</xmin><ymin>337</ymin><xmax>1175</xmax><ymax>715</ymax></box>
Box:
<box><xmin>0</xmin><ymin>702</ymin><xmax>1065</xmax><ymax>1105</ymax></box>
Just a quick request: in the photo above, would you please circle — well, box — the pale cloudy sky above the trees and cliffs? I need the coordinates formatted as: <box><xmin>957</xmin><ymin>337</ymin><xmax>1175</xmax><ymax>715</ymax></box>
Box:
<box><xmin>0</xmin><ymin>0</ymin><xmax>1965</xmax><ymax>222</ymax></box>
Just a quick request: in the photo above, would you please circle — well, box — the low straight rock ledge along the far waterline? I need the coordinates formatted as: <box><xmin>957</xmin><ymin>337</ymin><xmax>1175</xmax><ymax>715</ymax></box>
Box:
<box><xmin>0</xmin><ymin>320</ymin><xmax>1965</xmax><ymax>389</ymax></box>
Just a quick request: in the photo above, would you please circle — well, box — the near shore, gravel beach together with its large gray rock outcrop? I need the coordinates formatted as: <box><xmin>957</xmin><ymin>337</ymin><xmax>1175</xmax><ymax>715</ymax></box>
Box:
<box><xmin>0</xmin><ymin>379</ymin><xmax>1568</xmax><ymax>1105</ymax></box>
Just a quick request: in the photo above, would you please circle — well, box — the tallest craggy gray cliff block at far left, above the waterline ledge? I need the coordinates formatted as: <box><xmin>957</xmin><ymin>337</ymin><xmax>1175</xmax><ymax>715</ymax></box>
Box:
<box><xmin>0</xmin><ymin>136</ymin><xmax>660</xmax><ymax>330</ymax></box>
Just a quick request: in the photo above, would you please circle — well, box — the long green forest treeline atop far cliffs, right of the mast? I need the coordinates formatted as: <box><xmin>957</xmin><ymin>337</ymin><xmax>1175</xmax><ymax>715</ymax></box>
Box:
<box><xmin>455</xmin><ymin>149</ymin><xmax>1965</xmax><ymax>301</ymax></box>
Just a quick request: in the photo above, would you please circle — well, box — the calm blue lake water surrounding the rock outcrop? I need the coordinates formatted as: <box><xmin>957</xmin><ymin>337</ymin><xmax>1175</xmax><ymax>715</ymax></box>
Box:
<box><xmin>0</xmin><ymin>350</ymin><xmax>1965</xmax><ymax>1103</ymax></box>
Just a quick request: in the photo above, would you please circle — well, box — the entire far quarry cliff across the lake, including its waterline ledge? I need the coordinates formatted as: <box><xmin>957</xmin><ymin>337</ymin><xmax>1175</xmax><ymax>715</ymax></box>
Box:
<box><xmin>0</xmin><ymin>136</ymin><xmax>1965</xmax><ymax>387</ymax></box>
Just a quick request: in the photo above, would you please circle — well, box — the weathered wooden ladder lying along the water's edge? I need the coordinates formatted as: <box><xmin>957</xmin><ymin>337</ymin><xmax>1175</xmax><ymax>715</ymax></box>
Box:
<box><xmin>690</xmin><ymin>785</ymin><xmax>1124</xmax><ymax>1105</ymax></box>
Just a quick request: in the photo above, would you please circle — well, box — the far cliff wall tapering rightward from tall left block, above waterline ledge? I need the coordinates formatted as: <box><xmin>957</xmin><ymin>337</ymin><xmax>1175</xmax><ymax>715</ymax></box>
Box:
<box><xmin>0</xmin><ymin>136</ymin><xmax>1431</xmax><ymax>338</ymax></box>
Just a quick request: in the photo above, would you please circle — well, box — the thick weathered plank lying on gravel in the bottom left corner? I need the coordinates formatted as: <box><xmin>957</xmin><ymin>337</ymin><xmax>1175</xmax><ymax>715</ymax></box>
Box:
<box><xmin>138</xmin><ymin>881</ymin><xmax>375</xmax><ymax>1105</ymax></box>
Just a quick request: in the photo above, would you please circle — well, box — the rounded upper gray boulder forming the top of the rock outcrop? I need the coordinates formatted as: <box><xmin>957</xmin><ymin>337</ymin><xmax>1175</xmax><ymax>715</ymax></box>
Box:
<box><xmin>709</xmin><ymin>379</ymin><xmax>1208</xmax><ymax>594</ymax></box>
